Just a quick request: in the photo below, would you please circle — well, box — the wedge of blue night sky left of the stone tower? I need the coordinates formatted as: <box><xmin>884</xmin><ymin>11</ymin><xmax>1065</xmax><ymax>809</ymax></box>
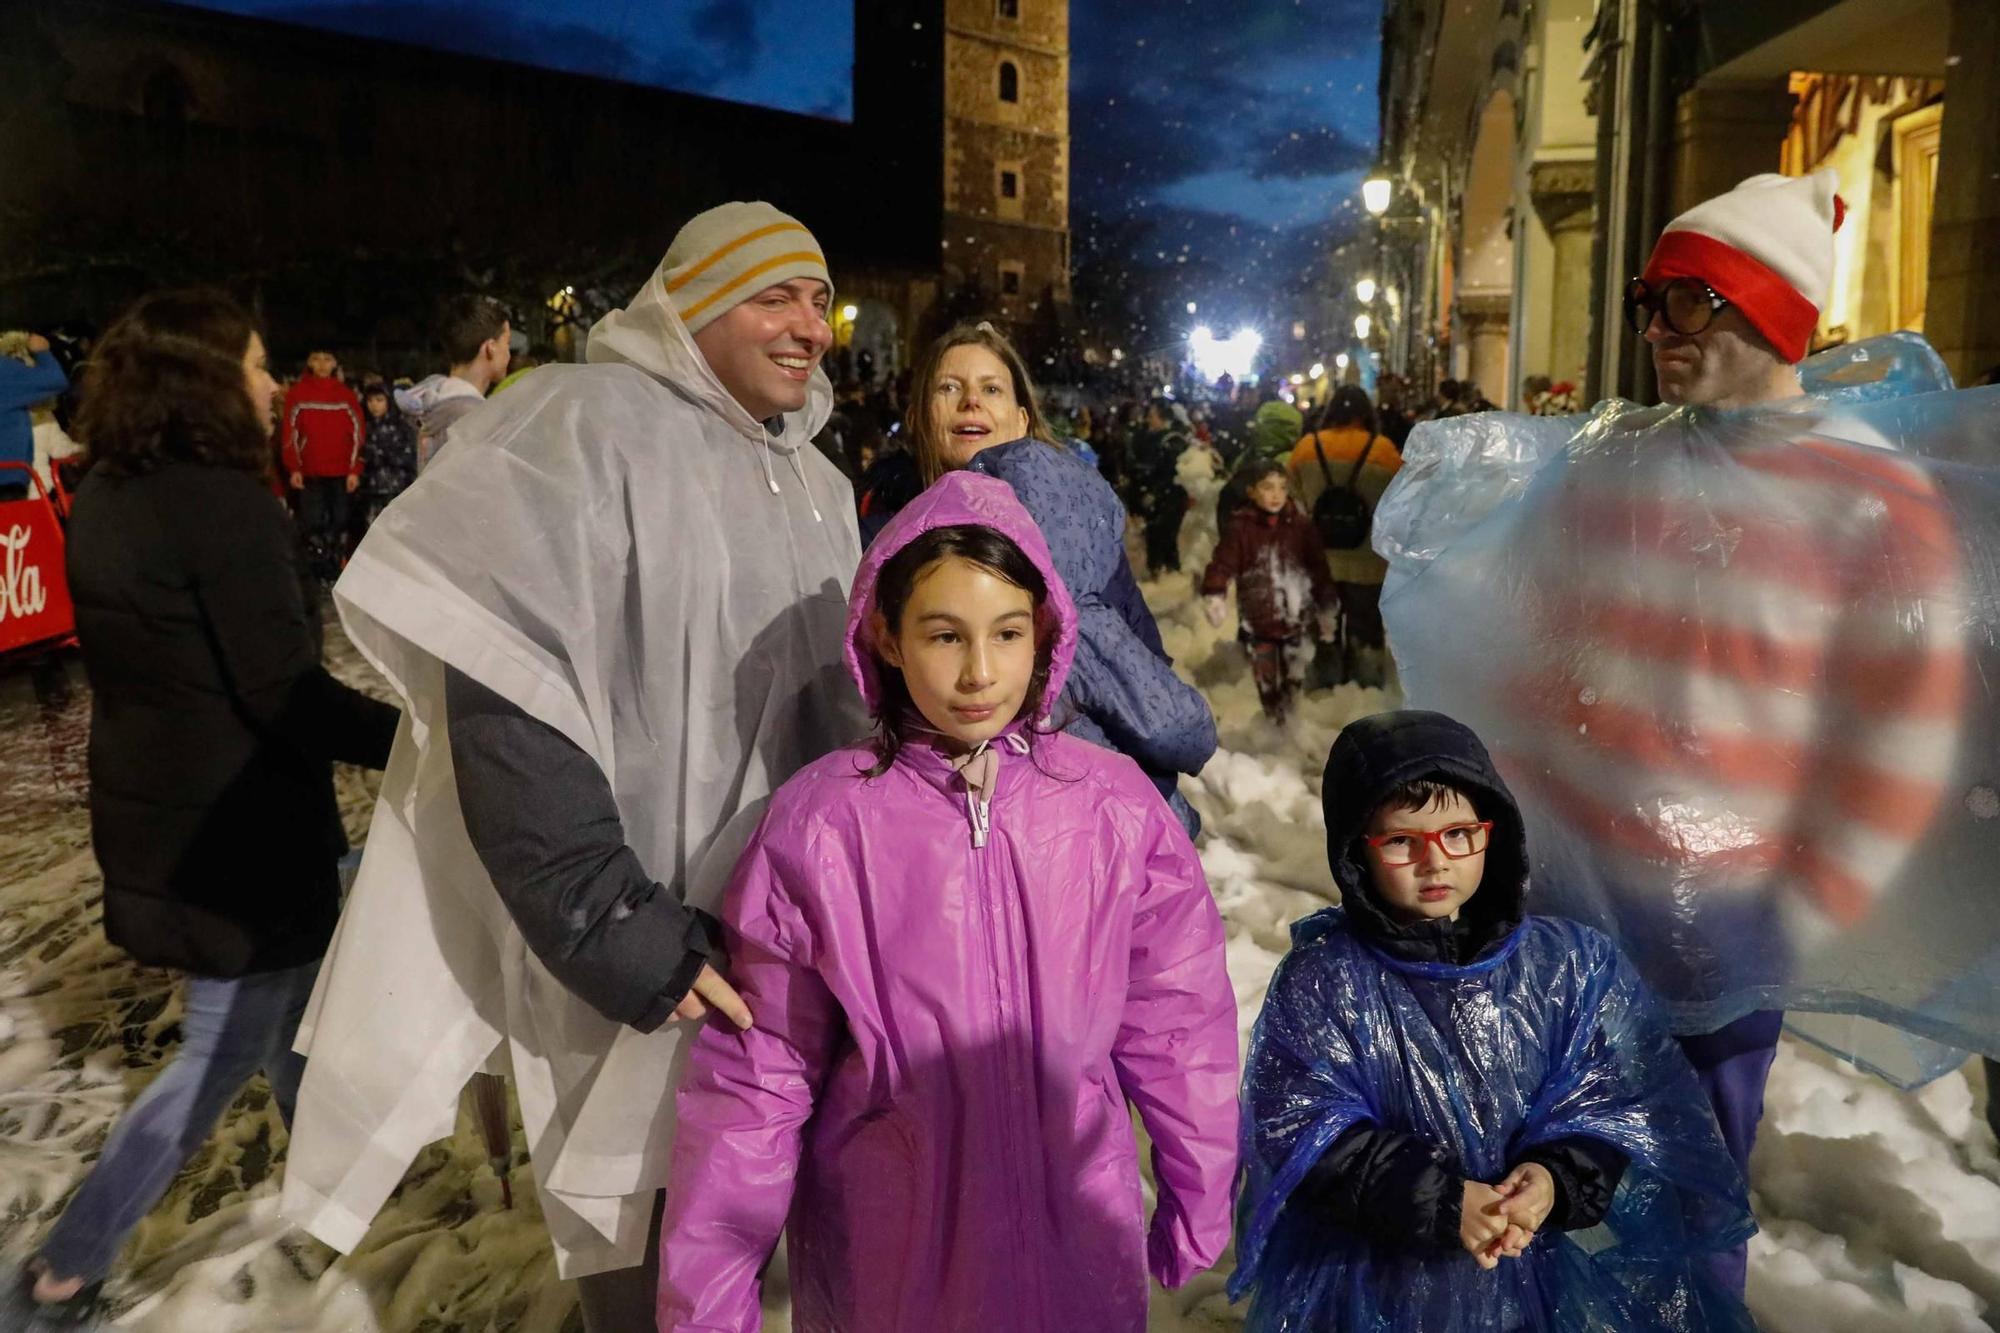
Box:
<box><xmin>170</xmin><ymin>0</ymin><xmax>854</xmax><ymax>120</ymax></box>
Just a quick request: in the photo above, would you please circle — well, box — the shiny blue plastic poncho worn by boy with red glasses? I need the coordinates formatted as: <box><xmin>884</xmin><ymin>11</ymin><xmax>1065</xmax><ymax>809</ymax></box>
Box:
<box><xmin>1230</xmin><ymin>909</ymin><xmax>1752</xmax><ymax>1333</ymax></box>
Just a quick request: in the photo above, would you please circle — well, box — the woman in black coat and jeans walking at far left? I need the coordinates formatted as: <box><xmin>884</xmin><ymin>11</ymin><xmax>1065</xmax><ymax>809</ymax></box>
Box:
<box><xmin>22</xmin><ymin>292</ymin><xmax>396</xmax><ymax>1313</ymax></box>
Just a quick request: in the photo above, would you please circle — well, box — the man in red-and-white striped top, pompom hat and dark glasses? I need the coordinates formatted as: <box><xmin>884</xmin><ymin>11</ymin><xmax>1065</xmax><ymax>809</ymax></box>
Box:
<box><xmin>1496</xmin><ymin>170</ymin><xmax>1966</xmax><ymax>1293</ymax></box>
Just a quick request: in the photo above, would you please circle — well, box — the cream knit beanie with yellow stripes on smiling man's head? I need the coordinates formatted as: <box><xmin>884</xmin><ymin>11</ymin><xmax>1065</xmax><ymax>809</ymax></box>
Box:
<box><xmin>662</xmin><ymin>202</ymin><xmax>834</xmax><ymax>334</ymax></box>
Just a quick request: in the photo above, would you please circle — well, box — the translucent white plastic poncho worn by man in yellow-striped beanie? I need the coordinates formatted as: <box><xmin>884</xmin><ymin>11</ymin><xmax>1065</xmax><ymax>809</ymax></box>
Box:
<box><xmin>284</xmin><ymin>272</ymin><xmax>866</xmax><ymax>1277</ymax></box>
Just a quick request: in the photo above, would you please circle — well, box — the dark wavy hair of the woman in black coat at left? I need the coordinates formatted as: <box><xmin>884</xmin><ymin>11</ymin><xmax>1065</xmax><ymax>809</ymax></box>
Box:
<box><xmin>76</xmin><ymin>288</ymin><xmax>272</xmax><ymax>476</ymax></box>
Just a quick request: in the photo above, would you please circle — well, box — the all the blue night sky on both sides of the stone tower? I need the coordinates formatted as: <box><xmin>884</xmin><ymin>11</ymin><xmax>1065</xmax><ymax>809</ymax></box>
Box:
<box><xmin>168</xmin><ymin>0</ymin><xmax>1382</xmax><ymax>348</ymax></box>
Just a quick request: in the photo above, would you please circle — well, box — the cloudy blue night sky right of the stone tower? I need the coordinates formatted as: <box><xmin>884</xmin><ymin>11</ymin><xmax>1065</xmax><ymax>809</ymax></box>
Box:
<box><xmin>1070</xmin><ymin>0</ymin><xmax>1382</xmax><ymax>348</ymax></box>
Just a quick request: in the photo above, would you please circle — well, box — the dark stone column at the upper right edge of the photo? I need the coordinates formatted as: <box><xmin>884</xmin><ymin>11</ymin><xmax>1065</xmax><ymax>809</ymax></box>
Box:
<box><xmin>1924</xmin><ymin>0</ymin><xmax>2000</xmax><ymax>384</ymax></box>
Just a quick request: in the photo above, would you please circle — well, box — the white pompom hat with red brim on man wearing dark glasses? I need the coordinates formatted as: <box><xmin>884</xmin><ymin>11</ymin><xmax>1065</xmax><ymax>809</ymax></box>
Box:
<box><xmin>1642</xmin><ymin>168</ymin><xmax>1848</xmax><ymax>362</ymax></box>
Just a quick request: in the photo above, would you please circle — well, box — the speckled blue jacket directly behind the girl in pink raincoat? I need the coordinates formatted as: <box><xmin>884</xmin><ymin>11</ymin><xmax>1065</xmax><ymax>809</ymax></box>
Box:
<box><xmin>970</xmin><ymin>440</ymin><xmax>1216</xmax><ymax>837</ymax></box>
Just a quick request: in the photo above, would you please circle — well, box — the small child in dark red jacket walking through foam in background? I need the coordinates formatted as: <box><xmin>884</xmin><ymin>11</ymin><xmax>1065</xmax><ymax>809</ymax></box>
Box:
<box><xmin>1202</xmin><ymin>460</ymin><xmax>1340</xmax><ymax>723</ymax></box>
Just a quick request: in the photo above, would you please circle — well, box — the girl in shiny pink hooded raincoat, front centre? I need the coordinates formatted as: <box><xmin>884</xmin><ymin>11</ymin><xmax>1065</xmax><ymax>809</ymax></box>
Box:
<box><xmin>660</xmin><ymin>472</ymin><xmax>1238</xmax><ymax>1333</ymax></box>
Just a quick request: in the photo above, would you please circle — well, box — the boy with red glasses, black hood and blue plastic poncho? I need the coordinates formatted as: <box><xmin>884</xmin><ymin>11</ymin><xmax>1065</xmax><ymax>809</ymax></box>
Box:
<box><xmin>1230</xmin><ymin>711</ymin><xmax>1754</xmax><ymax>1333</ymax></box>
